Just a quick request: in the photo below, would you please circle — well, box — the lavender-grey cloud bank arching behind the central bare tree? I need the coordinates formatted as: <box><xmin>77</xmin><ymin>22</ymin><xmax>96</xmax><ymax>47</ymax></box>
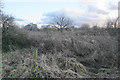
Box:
<box><xmin>42</xmin><ymin>8</ymin><xmax>99</xmax><ymax>26</ymax></box>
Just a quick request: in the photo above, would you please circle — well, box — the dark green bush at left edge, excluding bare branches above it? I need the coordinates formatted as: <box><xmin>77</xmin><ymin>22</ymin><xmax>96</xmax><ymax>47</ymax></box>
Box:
<box><xmin>2</xmin><ymin>27</ymin><xmax>30</xmax><ymax>52</ymax></box>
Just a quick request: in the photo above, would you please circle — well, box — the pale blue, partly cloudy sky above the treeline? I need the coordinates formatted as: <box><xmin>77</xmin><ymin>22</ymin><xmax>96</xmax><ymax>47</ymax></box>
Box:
<box><xmin>2</xmin><ymin>0</ymin><xmax>119</xmax><ymax>26</ymax></box>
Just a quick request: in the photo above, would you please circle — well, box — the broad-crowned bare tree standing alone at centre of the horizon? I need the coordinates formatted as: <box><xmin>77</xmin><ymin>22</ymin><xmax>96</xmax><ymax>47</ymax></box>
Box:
<box><xmin>53</xmin><ymin>15</ymin><xmax>73</xmax><ymax>29</ymax></box>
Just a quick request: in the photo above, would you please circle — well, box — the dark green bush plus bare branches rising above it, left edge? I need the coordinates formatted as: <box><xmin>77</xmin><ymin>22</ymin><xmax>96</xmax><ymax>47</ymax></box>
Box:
<box><xmin>1</xmin><ymin>14</ymin><xmax>30</xmax><ymax>52</ymax></box>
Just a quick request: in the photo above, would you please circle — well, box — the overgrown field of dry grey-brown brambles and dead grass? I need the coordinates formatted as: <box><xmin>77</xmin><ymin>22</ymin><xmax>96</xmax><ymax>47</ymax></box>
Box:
<box><xmin>2</xmin><ymin>28</ymin><xmax>119</xmax><ymax>78</ymax></box>
